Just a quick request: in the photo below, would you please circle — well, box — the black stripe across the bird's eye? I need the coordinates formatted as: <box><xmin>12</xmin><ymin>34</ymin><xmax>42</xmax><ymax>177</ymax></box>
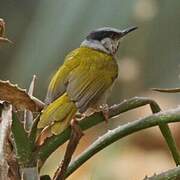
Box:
<box><xmin>86</xmin><ymin>31</ymin><xmax>119</xmax><ymax>41</ymax></box>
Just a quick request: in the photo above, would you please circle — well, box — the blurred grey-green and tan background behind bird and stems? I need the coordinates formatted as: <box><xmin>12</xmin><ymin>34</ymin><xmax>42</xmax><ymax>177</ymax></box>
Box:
<box><xmin>0</xmin><ymin>0</ymin><xmax>180</xmax><ymax>180</ymax></box>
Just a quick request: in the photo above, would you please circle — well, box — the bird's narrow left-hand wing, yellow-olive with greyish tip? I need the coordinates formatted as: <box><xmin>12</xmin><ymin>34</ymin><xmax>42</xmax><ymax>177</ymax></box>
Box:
<box><xmin>45</xmin><ymin>49</ymin><xmax>80</xmax><ymax>104</ymax></box>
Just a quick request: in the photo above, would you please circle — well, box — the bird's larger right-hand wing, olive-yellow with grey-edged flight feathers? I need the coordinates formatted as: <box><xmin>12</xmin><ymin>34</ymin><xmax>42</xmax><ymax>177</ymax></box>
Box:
<box><xmin>66</xmin><ymin>59</ymin><xmax>118</xmax><ymax>113</ymax></box>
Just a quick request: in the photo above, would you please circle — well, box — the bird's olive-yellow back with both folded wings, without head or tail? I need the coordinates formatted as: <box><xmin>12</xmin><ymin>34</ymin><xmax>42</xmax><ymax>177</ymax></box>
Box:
<box><xmin>46</xmin><ymin>48</ymin><xmax>118</xmax><ymax>112</ymax></box>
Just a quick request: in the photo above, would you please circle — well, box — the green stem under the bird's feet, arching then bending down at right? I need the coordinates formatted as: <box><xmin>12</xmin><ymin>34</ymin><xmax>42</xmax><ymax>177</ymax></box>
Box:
<box><xmin>37</xmin><ymin>97</ymin><xmax>179</xmax><ymax>162</ymax></box>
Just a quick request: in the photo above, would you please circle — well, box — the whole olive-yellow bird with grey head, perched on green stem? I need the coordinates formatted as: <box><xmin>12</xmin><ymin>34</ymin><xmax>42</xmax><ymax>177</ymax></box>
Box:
<box><xmin>38</xmin><ymin>26</ymin><xmax>137</xmax><ymax>135</ymax></box>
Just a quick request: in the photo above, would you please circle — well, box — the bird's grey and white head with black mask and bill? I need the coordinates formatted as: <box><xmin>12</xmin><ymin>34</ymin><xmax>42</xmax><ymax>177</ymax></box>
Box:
<box><xmin>81</xmin><ymin>27</ymin><xmax>137</xmax><ymax>55</ymax></box>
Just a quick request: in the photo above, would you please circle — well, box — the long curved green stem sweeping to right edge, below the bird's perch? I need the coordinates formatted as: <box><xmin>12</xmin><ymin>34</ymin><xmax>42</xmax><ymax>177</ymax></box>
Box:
<box><xmin>66</xmin><ymin>107</ymin><xmax>180</xmax><ymax>177</ymax></box>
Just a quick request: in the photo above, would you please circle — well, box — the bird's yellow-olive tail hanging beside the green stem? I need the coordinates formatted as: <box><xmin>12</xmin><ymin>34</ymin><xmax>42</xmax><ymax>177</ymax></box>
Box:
<box><xmin>38</xmin><ymin>93</ymin><xmax>77</xmax><ymax>135</ymax></box>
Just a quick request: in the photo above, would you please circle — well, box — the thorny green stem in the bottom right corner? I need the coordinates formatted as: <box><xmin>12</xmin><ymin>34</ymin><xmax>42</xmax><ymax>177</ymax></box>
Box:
<box><xmin>144</xmin><ymin>167</ymin><xmax>180</xmax><ymax>180</ymax></box>
